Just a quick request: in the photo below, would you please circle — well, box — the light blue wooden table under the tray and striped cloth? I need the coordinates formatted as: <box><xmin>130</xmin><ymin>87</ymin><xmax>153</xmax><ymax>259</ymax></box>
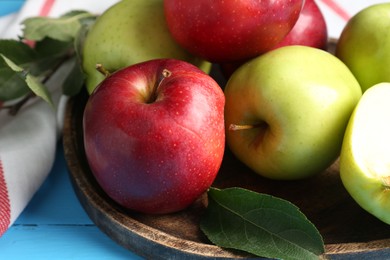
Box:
<box><xmin>0</xmin><ymin>3</ymin><xmax>141</xmax><ymax>260</ymax></box>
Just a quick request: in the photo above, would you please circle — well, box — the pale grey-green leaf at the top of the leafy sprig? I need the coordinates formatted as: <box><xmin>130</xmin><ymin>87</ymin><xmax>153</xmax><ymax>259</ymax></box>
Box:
<box><xmin>22</xmin><ymin>10</ymin><xmax>95</xmax><ymax>41</ymax></box>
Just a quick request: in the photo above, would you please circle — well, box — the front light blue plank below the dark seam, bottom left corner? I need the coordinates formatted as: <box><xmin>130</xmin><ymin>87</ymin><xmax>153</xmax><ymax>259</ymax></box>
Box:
<box><xmin>0</xmin><ymin>225</ymin><xmax>142</xmax><ymax>260</ymax></box>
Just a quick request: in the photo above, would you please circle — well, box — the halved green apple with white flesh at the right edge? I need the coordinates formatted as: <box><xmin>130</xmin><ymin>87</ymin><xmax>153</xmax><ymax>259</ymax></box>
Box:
<box><xmin>340</xmin><ymin>83</ymin><xmax>390</xmax><ymax>224</ymax></box>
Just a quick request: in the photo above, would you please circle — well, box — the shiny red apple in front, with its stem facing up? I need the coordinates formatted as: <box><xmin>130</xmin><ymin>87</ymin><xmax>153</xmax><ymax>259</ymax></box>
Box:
<box><xmin>83</xmin><ymin>59</ymin><xmax>225</xmax><ymax>213</ymax></box>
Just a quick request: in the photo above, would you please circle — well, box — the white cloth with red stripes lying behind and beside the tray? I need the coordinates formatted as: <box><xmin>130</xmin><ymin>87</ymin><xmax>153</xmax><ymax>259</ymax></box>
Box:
<box><xmin>0</xmin><ymin>0</ymin><xmax>384</xmax><ymax>237</ymax></box>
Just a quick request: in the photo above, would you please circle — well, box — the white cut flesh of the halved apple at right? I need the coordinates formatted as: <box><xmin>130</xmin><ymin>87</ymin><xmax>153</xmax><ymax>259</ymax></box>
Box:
<box><xmin>352</xmin><ymin>84</ymin><xmax>390</xmax><ymax>187</ymax></box>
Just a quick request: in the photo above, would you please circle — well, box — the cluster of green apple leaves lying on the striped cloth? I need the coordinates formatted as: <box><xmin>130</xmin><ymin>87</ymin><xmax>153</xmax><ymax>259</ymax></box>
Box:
<box><xmin>0</xmin><ymin>10</ymin><xmax>93</xmax><ymax>114</ymax></box>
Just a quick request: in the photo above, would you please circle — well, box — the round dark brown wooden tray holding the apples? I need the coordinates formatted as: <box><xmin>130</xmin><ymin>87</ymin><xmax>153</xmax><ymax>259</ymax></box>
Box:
<box><xmin>63</xmin><ymin>62</ymin><xmax>390</xmax><ymax>259</ymax></box>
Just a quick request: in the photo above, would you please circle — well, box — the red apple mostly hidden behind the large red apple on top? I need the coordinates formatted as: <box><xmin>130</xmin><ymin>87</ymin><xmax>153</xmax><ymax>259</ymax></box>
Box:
<box><xmin>272</xmin><ymin>0</ymin><xmax>328</xmax><ymax>50</ymax></box>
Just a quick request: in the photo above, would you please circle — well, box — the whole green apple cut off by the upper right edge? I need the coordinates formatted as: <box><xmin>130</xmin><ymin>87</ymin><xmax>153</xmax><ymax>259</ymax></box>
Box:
<box><xmin>336</xmin><ymin>3</ymin><xmax>390</xmax><ymax>92</ymax></box>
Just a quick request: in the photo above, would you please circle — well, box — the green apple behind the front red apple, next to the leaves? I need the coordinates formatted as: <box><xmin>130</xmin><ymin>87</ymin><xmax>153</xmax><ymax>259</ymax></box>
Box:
<box><xmin>82</xmin><ymin>0</ymin><xmax>211</xmax><ymax>93</ymax></box>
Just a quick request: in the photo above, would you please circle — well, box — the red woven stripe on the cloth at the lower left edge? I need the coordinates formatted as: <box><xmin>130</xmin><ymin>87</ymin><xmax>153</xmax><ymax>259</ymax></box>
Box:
<box><xmin>0</xmin><ymin>160</ymin><xmax>11</xmax><ymax>237</ymax></box>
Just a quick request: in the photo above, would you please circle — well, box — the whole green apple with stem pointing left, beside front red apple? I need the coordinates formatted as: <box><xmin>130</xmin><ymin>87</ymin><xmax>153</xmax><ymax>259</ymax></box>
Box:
<box><xmin>225</xmin><ymin>46</ymin><xmax>362</xmax><ymax>180</ymax></box>
